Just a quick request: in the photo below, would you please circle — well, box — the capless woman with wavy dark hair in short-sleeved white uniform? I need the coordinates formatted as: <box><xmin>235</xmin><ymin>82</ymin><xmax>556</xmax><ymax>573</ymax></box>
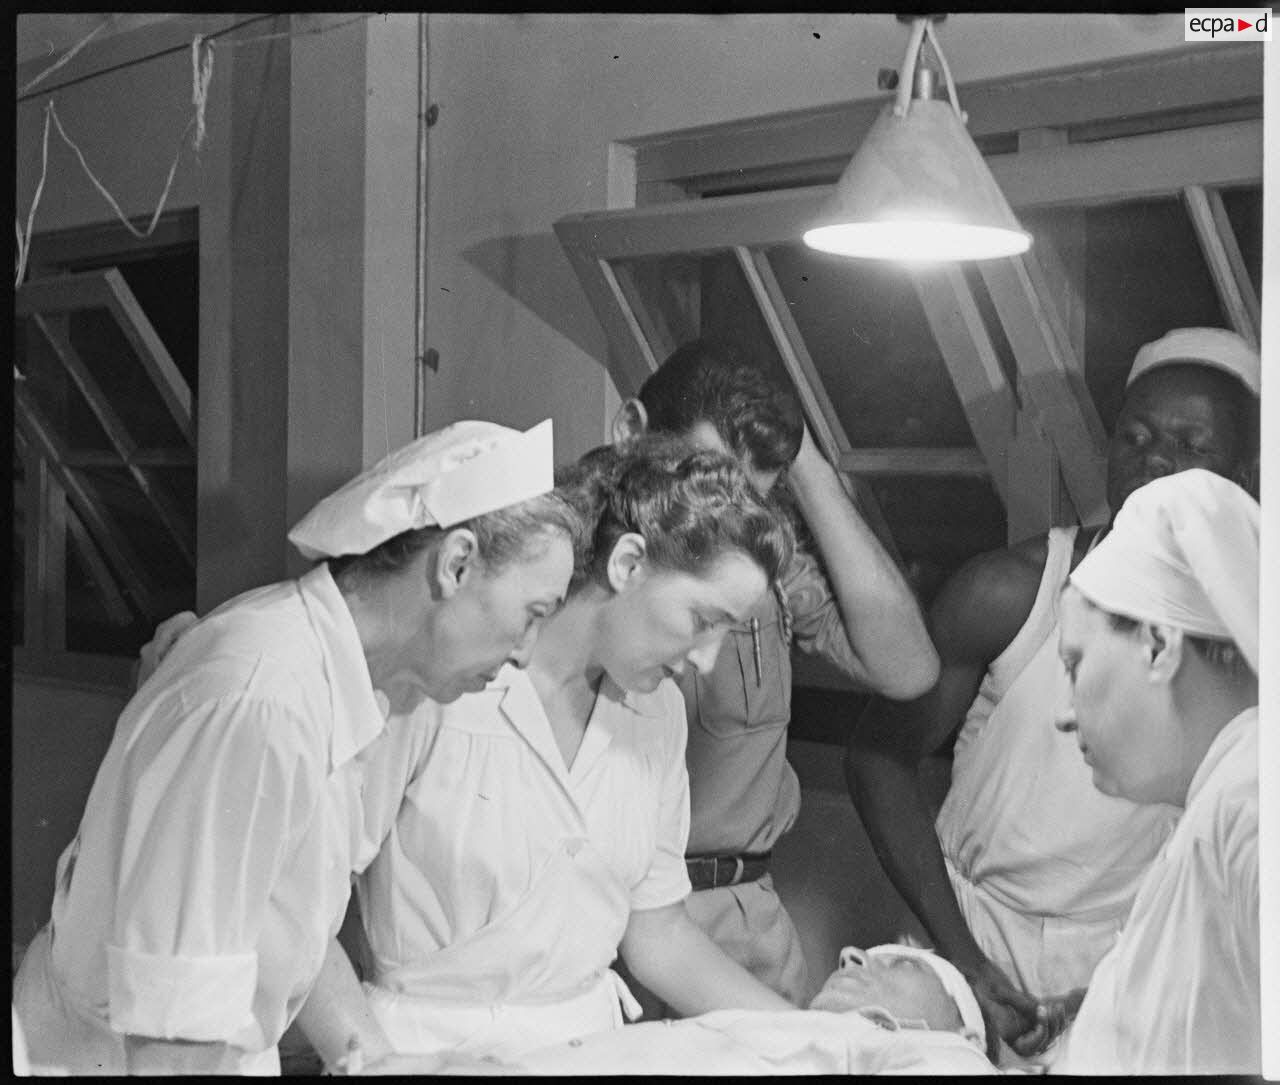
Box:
<box><xmin>300</xmin><ymin>439</ymin><xmax>792</xmax><ymax>1066</ymax></box>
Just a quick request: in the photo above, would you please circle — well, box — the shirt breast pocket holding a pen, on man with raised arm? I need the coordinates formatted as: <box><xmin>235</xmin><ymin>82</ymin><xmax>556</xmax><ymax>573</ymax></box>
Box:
<box><xmin>694</xmin><ymin>615</ymin><xmax>791</xmax><ymax>738</ymax></box>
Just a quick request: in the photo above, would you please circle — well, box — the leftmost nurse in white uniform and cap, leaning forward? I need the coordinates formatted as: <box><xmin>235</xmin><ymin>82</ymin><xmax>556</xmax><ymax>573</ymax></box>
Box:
<box><xmin>14</xmin><ymin>421</ymin><xmax>581</xmax><ymax>1073</ymax></box>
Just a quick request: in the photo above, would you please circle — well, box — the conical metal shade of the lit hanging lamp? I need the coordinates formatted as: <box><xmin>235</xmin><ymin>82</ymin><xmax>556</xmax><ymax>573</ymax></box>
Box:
<box><xmin>804</xmin><ymin>99</ymin><xmax>1032</xmax><ymax>261</ymax></box>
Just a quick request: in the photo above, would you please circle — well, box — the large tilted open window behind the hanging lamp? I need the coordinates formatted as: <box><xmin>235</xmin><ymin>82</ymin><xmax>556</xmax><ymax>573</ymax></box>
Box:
<box><xmin>556</xmin><ymin>46</ymin><xmax>1262</xmax><ymax>609</ymax></box>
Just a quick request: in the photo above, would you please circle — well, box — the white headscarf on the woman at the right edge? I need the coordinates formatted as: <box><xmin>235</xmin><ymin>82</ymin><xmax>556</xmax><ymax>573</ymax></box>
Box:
<box><xmin>1070</xmin><ymin>467</ymin><xmax>1260</xmax><ymax>674</ymax></box>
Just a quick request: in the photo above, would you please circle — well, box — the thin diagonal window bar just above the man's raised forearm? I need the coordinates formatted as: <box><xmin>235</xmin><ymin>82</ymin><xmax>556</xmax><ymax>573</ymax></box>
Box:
<box><xmin>733</xmin><ymin>246</ymin><xmax>904</xmax><ymax>568</ymax></box>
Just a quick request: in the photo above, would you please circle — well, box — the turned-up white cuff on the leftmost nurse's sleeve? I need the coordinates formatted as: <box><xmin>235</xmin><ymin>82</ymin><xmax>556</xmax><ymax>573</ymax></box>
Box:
<box><xmin>106</xmin><ymin>946</ymin><xmax>257</xmax><ymax>1043</ymax></box>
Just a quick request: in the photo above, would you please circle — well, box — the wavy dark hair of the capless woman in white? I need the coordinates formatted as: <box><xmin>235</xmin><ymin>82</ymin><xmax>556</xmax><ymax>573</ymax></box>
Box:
<box><xmin>557</xmin><ymin>434</ymin><xmax>794</xmax><ymax>594</ymax></box>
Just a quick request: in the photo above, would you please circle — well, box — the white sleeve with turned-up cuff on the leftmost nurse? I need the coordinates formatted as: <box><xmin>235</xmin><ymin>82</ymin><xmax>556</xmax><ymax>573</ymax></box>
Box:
<box><xmin>106</xmin><ymin>696</ymin><xmax>325</xmax><ymax>1041</ymax></box>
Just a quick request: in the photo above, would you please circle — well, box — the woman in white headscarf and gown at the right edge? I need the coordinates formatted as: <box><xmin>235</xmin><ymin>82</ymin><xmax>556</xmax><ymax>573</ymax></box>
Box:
<box><xmin>1052</xmin><ymin>470</ymin><xmax>1261</xmax><ymax>1075</ymax></box>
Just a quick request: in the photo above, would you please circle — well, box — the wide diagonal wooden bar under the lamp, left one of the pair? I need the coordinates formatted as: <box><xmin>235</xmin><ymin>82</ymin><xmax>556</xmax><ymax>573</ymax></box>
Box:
<box><xmin>911</xmin><ymin>266</ymin><xmax>1016</xmax><ymax>508</ymax></box>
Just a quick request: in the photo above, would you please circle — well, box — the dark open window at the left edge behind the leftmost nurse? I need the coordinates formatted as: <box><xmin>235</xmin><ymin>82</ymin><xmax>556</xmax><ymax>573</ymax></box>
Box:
<box><xmin>13</xmin><ymin>213</ymin><xmax>198</xmax><ymax>681</ymax></box>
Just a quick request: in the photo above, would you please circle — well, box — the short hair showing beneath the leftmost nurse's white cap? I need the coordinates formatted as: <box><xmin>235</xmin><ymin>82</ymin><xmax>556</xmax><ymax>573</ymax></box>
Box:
<box><xmin>329</xmin><ymin>491</ymin><xmax>583</xmax><ymax>587</ymax></box>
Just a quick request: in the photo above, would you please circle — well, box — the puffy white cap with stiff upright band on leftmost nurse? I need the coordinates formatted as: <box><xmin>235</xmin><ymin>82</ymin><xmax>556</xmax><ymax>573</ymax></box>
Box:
<box><xmin>289</xmin><ymin>418</ymin><xmax>554</xmax><ymax>560</ymax></box>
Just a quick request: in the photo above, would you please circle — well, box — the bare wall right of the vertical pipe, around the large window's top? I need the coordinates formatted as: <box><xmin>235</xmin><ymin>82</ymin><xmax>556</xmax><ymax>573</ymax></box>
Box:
<box><xmin>417</xmin><ymin>13</ymin><xmax>1185</xmax><ymax>458</ymax></box>
